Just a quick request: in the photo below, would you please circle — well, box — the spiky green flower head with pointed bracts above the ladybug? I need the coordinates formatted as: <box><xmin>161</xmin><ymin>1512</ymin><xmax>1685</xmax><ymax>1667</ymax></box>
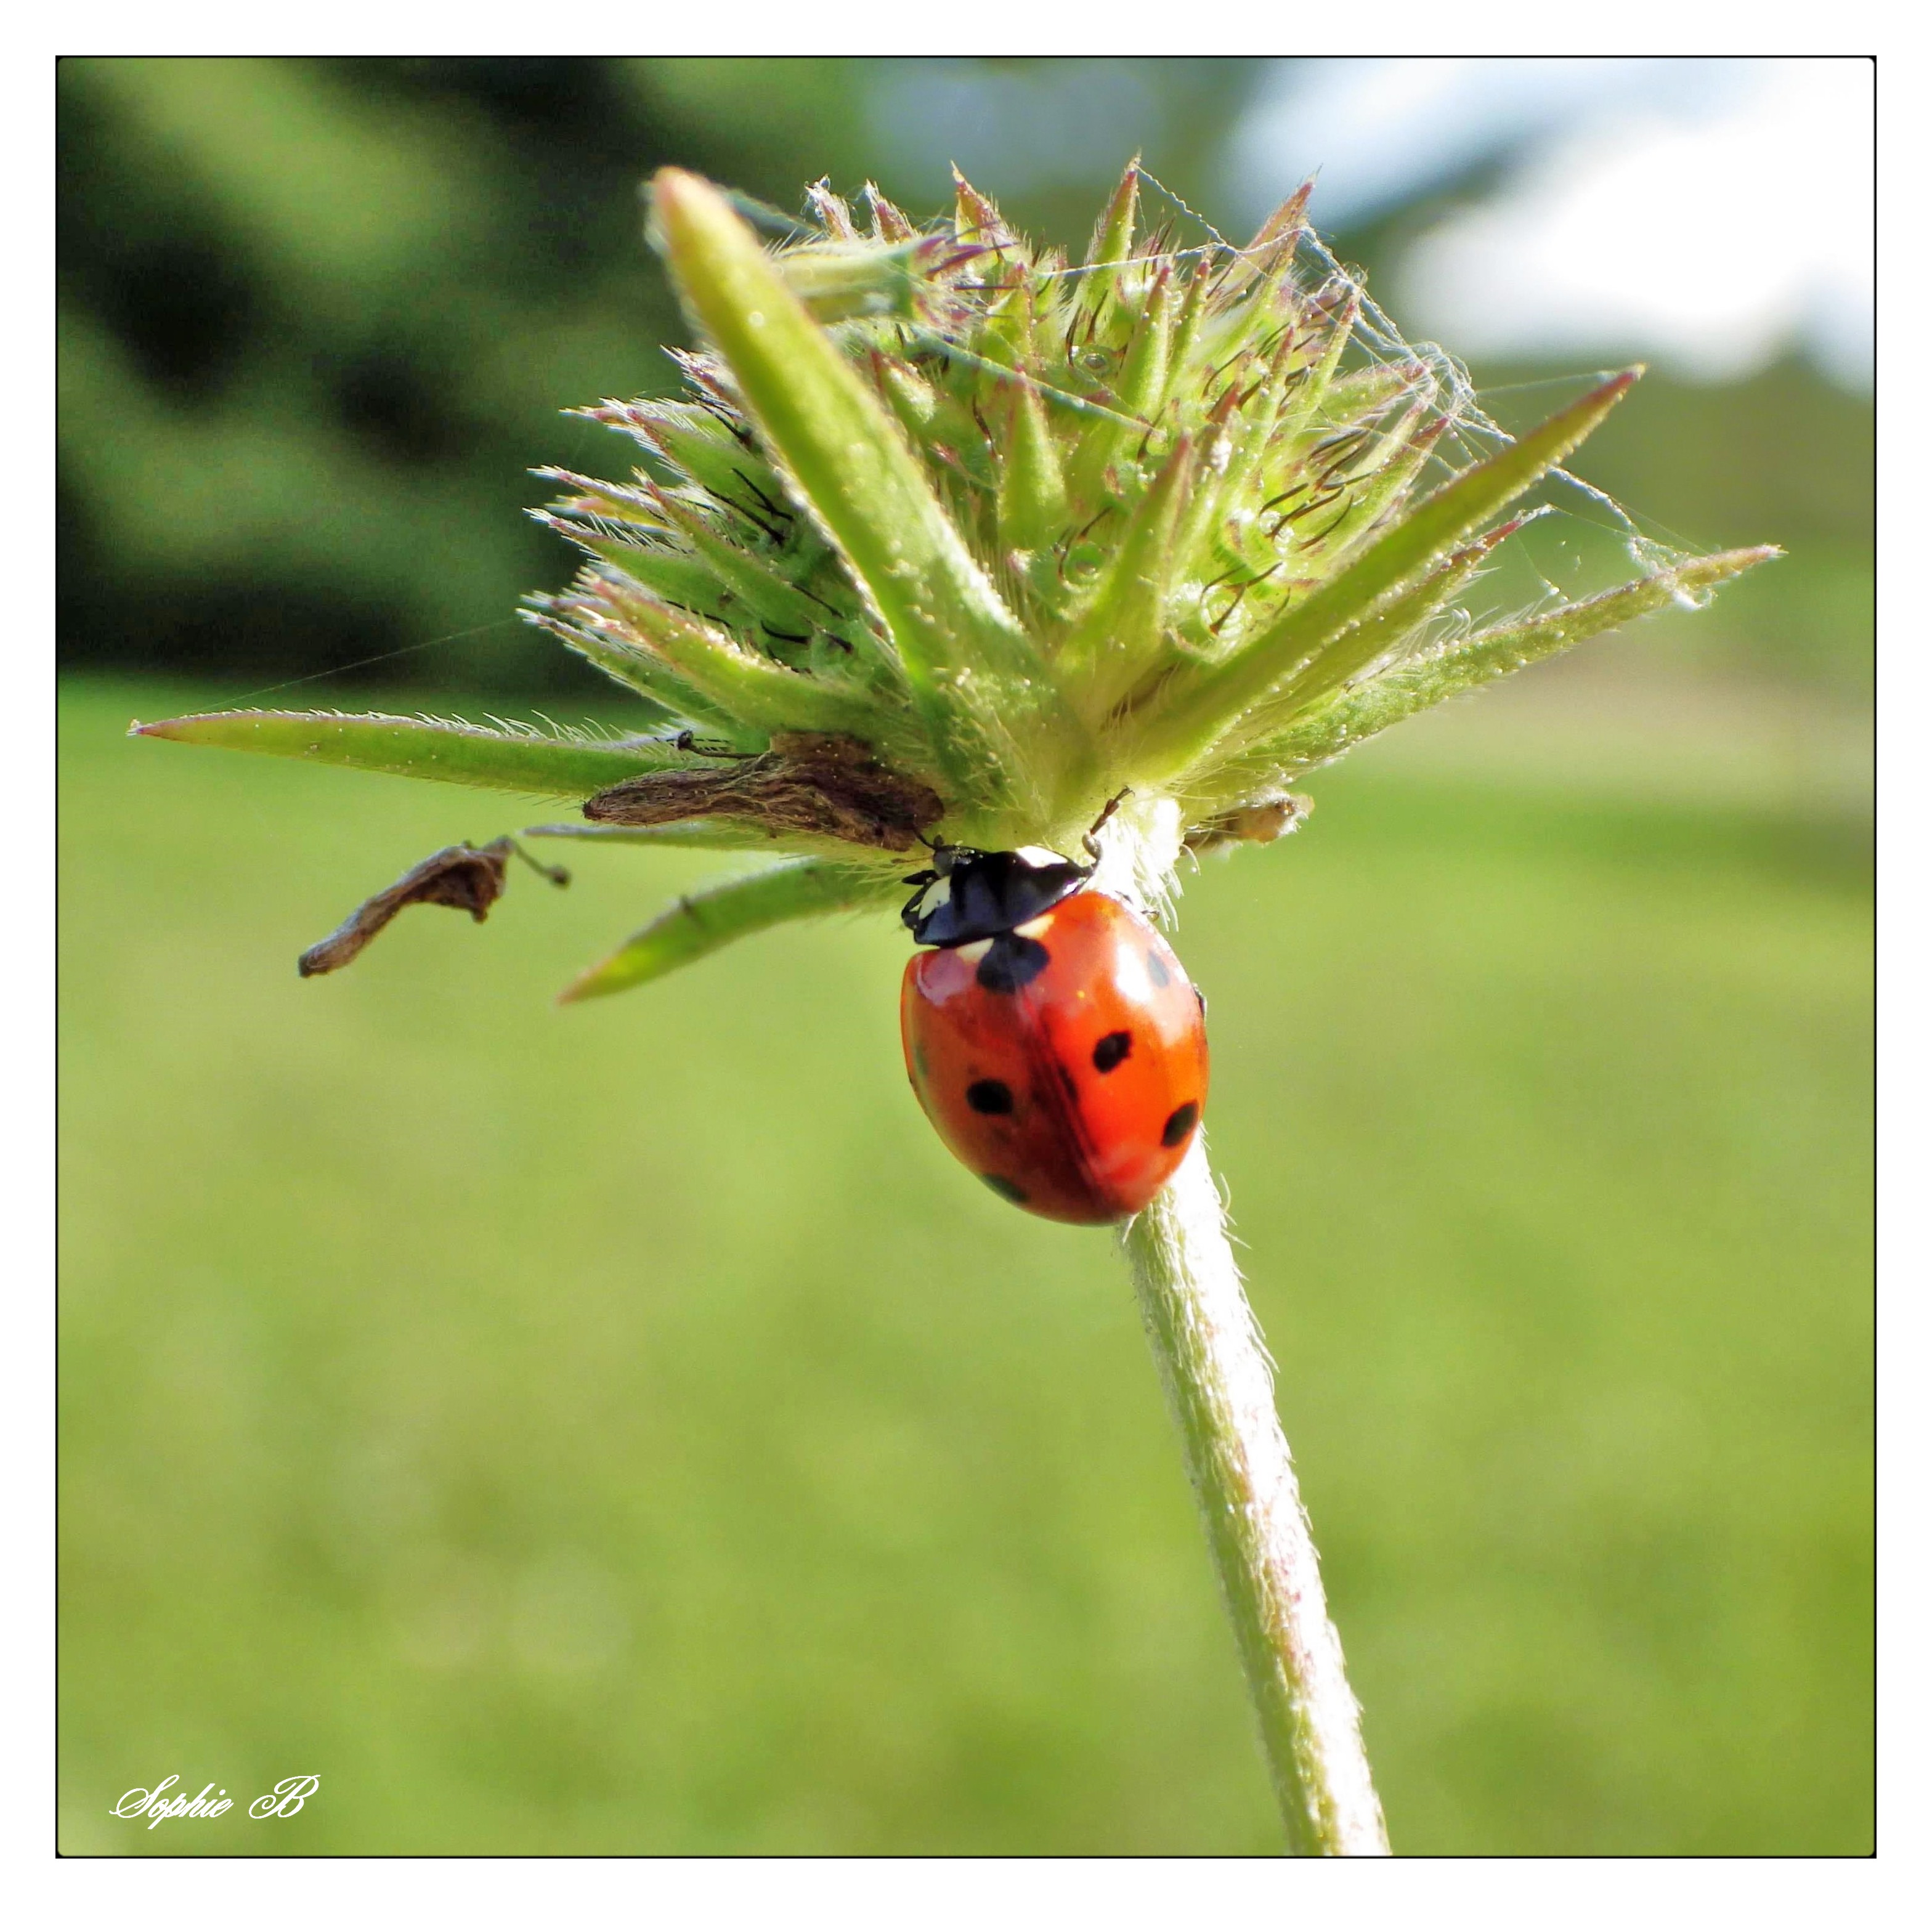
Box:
<box><xmin>136</xmin><ymin>166</ymin><xmax>1772</xmax><ymax>995</ymax></box>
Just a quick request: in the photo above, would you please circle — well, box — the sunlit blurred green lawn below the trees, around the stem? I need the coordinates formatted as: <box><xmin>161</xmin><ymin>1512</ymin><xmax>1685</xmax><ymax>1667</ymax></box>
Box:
<box><xmin>60</xmin><ymin>682</ymin><xmax>1872</xmax><ymax>1854</ymax></box>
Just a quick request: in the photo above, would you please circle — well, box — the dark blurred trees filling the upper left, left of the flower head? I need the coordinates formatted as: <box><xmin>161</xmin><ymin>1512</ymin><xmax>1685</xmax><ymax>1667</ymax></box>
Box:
<box><xmin>58</xmin><ymin>60</ymin><xmax>888</xmax><ymax>689</ymax></box>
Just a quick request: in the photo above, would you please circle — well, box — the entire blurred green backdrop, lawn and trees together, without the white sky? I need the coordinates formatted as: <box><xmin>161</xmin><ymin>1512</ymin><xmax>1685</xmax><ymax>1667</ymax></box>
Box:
<box><xmin>58</xmin><ymin>60</ymin><xmax>1874</xmax><ymax>1852</ymax></box>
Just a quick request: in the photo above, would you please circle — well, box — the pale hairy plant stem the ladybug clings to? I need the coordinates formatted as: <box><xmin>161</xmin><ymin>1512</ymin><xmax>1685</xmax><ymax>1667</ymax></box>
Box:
<box><xmin>1102</xmin><ymin>803</ymin><xmax>1389</xmax><ymax>1854</ymax></box>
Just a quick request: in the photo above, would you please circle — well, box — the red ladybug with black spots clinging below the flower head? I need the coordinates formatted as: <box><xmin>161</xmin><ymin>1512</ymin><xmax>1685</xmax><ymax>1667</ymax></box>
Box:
<box><xmin>898</xmin><ymin>846</ymin><xmax>1208</xmax><ymax>1223</ymax></box>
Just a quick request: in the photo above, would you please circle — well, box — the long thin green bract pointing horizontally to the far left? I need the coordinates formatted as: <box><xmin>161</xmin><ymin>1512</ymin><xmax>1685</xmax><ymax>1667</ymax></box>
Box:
<box><xmin>128</xmin><ymin>711</ymin><xmax>688</xmax><ymax>798</ymax></box>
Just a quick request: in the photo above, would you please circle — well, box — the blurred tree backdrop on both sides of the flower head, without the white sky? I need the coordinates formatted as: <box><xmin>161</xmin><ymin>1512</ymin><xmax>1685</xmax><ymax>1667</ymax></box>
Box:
<box><xmin>56</xmin><ymin>58</ymin><xmax>1872</xmax><ymax>703</ymax></box>
